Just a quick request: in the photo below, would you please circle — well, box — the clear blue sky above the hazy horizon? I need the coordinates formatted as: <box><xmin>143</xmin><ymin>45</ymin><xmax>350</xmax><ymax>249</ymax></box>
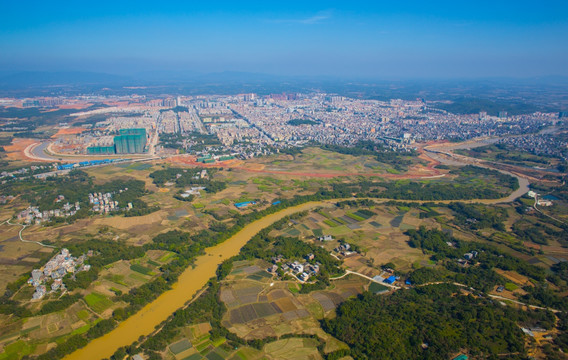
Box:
<box><xmin>0</xmin><ymin>0</ymin><xmax>568</xmax><ymax>78</ymax></box>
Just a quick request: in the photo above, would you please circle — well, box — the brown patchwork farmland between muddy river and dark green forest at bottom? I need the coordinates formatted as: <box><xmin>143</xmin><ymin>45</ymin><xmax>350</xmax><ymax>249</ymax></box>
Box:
<box><xmin>219</xmin><ymin>260</ymin><xmax>369</xmax><ymax>351</ymax></box>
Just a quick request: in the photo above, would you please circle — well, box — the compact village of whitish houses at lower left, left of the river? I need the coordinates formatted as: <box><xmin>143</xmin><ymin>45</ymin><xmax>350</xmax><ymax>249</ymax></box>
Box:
<box><xmin>28</xmin><ymin>249</ymin><xmax>91</xmax><ymax>300</ymax></box>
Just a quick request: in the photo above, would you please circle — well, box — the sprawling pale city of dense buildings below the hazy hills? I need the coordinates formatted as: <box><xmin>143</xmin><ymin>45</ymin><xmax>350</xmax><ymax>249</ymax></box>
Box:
<box><xmin>10</xmin><ymin>92</ymin><xmax>567</xmax><ymax>166</ymax></box>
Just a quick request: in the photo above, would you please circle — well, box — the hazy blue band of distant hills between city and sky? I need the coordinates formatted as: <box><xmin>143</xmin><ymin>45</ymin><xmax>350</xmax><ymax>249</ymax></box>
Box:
<box><xmin>0</xmin><ymin>71</ymin><xmax>568</xmax><ymax>112</ymax></box>
